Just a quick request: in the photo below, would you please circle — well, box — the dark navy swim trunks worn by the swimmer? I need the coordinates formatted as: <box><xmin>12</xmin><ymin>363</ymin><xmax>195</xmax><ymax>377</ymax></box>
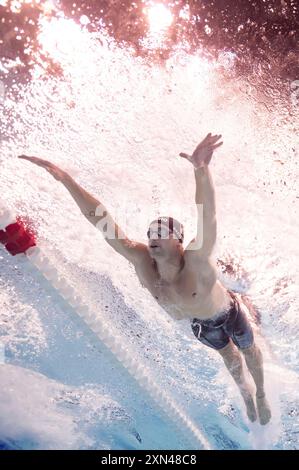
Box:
<box><xmin>191</xmin><ymin>290</ymin><xmax>253</xmax><ymax>350</ymax></box>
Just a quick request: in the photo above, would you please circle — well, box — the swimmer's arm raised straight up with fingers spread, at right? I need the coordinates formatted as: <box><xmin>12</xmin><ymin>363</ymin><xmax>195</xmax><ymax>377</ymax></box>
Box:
<box><xmin>180</xmin><ymin>134</ymin><xmax>222</xmax><ymax>257</ymax></box>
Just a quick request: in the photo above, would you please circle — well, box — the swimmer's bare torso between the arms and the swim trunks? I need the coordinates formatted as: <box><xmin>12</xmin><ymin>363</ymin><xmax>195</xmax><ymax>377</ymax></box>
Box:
<box><xmin>135</xmin><ymin>252</ymin><xmax>230</xmax><ymax>320</ymax></box>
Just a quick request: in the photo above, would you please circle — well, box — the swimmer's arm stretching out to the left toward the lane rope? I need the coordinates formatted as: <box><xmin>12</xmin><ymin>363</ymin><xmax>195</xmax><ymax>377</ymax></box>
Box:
<box><xmin>19</xmin><ymin>155</ymin><xmax>146</xmax><ymax>263</ymax></box>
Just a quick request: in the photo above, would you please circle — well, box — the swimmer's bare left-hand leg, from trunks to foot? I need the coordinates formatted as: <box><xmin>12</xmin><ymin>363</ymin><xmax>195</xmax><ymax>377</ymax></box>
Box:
<box><xmin>218</xmin><ymin>341</ymin><xmax>257</xmax><ymax>422</ymax></box>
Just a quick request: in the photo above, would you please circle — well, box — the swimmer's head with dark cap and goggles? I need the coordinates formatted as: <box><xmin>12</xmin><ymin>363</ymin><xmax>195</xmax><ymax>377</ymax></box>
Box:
<box><xmin>147</xmin><ymin>224</ymin><xmax>182</xmax><ymax>258</ymax></box>
